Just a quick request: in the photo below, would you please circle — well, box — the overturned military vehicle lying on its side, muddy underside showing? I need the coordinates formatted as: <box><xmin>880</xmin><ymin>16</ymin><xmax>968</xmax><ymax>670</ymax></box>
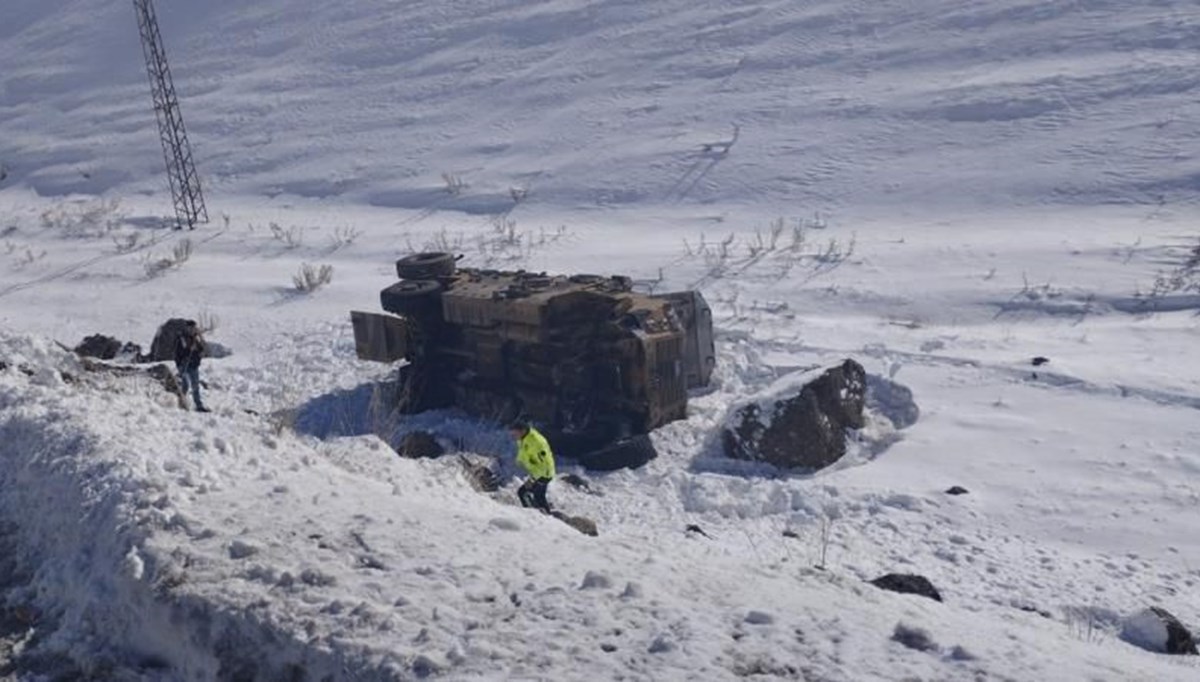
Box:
<box><xmin>350</xmin><ymin>253</ymin><xmax>715</xmax><ymax>469</ymax></box>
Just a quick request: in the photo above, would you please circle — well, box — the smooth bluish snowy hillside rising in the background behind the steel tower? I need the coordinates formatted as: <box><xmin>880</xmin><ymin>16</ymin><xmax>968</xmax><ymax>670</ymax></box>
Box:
<box><xmin>0</xmin><ymin>0</ymin><xmax>1200</xmax><ymax>213</ymax></box>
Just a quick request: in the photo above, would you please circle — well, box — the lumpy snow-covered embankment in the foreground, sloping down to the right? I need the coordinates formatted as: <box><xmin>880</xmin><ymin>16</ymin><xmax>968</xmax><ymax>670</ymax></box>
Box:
<box><xmin>0</xmin><ymin>335</ymin><xmax>1196</xmax><ymax>681</ymax></box>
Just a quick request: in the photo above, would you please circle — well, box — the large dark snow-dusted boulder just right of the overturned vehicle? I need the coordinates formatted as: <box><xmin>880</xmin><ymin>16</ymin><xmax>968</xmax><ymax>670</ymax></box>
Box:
<box><xmin>722</xmin><ymin>359</ymin><xmax>866</xmax><ymax>469</ymax></box>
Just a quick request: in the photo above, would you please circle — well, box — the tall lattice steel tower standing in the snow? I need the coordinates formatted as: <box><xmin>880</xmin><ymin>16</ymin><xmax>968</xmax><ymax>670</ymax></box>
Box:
<box><xmin>133</xmin><ymin>0</ymin><xmax>209</xmax><ymax>229</ymax></box>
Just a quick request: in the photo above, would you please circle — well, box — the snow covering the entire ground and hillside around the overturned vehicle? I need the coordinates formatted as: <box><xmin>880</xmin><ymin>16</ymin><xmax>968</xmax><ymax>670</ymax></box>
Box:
<box><xmin>0</xmin><ymin>0</ymin><xmax>1200</xmax><ymax>681</ymax></box>
